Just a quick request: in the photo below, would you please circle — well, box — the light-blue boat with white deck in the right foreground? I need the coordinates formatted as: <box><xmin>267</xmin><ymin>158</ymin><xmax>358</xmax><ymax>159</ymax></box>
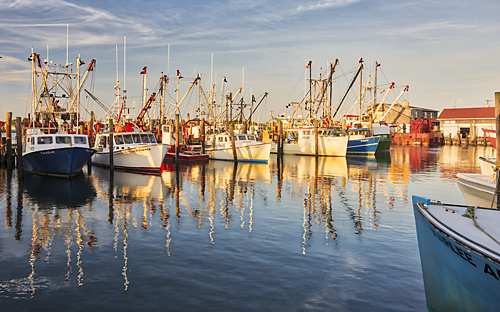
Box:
<box><xmin>413</xmin><ymin>196</ymin><xmax>500</xmax><ymax>311</ymax></box>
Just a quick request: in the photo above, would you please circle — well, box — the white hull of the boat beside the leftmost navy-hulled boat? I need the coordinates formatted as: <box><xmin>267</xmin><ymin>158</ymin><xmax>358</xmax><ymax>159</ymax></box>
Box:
<box><xmin>92</xmin><ymin>144</ymin><xmax>170</xmax><ymax>172</ymax></box>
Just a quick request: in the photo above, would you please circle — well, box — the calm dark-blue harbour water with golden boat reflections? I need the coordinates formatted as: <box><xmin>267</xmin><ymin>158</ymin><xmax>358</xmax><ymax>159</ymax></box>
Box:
<box><xmin>0</xmin><ymin>146</ymin><xmax>492</xmax><ymax>311</ymax></box>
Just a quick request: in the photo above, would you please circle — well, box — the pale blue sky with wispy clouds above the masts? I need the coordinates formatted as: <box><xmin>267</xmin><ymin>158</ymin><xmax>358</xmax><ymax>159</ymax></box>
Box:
<box><xmin>0</xmin><ymin>0</ymin><xmax>500</xmax><ymax>121</ymax></box>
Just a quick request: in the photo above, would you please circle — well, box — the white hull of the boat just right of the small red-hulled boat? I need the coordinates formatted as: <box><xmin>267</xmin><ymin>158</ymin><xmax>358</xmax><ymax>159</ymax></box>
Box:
<box><xmin>207</xmin><ymin>142</ymin><xmax>271</xmax><ymax>163</ymax></box>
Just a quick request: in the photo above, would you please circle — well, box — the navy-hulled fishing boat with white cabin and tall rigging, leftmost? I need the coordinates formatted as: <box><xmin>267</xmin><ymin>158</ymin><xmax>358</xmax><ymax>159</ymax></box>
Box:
<box><xmin>23</xmin><ymin>52</ymin><xmax>95</xmax><ymax>178</ymax></box>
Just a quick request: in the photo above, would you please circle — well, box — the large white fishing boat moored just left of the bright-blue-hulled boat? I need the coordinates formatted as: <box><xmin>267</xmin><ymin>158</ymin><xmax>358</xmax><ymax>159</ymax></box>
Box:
<box><xmin>272</xmin><ymin>127</ymin><xmax>349</xmax><ymax>157</ymax></box>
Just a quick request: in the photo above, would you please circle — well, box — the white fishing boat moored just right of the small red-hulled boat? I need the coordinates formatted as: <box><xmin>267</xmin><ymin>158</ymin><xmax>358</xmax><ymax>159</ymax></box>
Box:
<box><xmin>206</xmin><ymin>133</ymin><xmax>271</xmax><ymax>163</ymax></box>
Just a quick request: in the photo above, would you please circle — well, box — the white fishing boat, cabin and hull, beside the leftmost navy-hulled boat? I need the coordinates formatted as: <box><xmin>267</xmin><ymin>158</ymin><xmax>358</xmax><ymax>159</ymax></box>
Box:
<box><xmin>92</xmin><ymin>130</ymin><xmax>167</xmax><ymax>172</ymax></box>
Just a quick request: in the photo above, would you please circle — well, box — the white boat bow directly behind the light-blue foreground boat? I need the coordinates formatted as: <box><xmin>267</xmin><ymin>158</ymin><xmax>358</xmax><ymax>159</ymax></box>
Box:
<box><xmin>457</xmin><ymin>173</ymin><xmax>496</xmax><ymax>207</ymax></box>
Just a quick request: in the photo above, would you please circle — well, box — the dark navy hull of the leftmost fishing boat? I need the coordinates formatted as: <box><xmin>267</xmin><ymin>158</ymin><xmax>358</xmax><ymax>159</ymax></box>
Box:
<box><xmin>23</xmin><ymin>147</ymin><xmax>96</xmax><ymax>178</ymax></box>
